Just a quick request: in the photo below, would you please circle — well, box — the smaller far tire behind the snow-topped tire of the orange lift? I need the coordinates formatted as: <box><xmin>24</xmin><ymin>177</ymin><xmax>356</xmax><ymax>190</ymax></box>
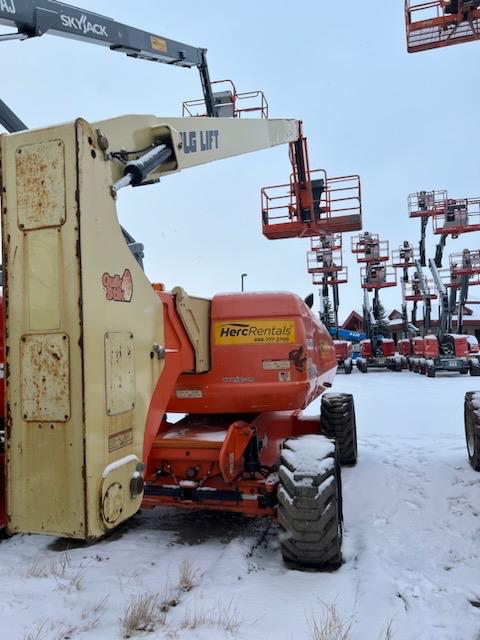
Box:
<box><xmin>320</xmin><ymin>393</ymin><xmax>358</xmax><ymax>467</ymax></box>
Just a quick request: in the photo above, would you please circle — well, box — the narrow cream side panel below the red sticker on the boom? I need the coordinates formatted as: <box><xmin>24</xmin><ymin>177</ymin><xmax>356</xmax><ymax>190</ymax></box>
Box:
<box><xmin>105</xmin><ymin>331</ymin><xmax>135</xmax><ymax>416</ymax></box>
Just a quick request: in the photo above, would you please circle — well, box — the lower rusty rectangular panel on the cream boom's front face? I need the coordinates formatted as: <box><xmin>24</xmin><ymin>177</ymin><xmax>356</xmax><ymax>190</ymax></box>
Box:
<box><xmin>20</xmin><ymin>333</ymin><xmax>70</xmax><ymax>422</ymax></box>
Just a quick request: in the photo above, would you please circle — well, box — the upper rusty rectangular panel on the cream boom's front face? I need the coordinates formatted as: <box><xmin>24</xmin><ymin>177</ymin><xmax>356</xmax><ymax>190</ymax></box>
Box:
<box><xmin>15</xmin><ymin>140</ymin><xmax>66</xmax><ymax>231</ymax></box>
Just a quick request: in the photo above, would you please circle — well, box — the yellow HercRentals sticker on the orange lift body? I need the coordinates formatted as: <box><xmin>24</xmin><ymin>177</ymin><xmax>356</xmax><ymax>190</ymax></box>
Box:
<box><xmin>213</xmin><ymin>320</ymin><xmax>296</xmax><ymax>345</ymax></box>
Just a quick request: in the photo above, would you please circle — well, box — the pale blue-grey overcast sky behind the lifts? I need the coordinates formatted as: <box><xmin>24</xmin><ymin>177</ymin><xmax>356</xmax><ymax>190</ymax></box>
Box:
<box><xmin>0</xmin><ymin>0</ymin><xmax>480</xmax><ymax>318</ymax></box>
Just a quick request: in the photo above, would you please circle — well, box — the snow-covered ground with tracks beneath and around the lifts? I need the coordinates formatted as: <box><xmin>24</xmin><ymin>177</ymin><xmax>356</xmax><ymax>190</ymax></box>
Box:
<box><xmin>0</xmin><ymin>372</ymin><xmax>480</xmax><ymax>640</ymax></box>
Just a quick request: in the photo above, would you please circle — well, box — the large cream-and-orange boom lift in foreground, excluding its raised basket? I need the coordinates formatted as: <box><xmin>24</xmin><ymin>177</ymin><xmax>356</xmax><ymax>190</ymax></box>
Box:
<box><xmin>0</xmin><ymin>116</ymin><xmax>356</xmax><ymax>568</ymax></box>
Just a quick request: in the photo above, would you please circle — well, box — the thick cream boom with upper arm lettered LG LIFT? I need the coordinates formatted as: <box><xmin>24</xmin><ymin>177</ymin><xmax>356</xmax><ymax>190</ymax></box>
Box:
<box><xmin>0</xmin><ymin>116</ymin><xmax>304</xmax><ymax>539</ymax></box>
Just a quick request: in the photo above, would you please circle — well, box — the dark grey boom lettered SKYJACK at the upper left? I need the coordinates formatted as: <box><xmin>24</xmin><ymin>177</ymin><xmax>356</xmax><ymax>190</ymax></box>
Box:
<box><xmin>0</xmin><ymin>0</ymin><xmax>216</xmax><ymax>132</ymax></box>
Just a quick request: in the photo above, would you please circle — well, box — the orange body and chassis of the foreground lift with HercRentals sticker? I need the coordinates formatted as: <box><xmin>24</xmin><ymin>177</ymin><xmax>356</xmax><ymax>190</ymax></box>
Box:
<box><xmin>144</xmin><ymin>293</ymin><xmax>337</xmax><ymax>516</ymax></box>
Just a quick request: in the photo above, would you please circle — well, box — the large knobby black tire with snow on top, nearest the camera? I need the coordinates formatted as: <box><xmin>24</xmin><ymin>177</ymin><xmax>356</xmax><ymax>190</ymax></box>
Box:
<box><xmin>278</xmin><ymin>435</ymin><xmax>343</xmax><ymax>571</ymax></box>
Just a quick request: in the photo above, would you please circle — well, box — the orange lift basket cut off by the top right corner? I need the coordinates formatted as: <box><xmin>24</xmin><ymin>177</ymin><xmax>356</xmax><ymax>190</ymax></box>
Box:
<box><xmin>405</xmin><ymin>0</ymin><xmax>480</xmax><ymax>53</ymax></box>
